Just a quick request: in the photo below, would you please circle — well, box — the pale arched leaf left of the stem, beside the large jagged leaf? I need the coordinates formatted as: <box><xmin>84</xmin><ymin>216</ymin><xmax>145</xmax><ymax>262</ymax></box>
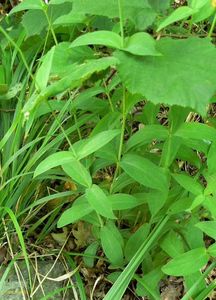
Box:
<box><xmin>71</xmin><ymin>30</ymin><xmax>121</xmax><ymax>49</ymax></box>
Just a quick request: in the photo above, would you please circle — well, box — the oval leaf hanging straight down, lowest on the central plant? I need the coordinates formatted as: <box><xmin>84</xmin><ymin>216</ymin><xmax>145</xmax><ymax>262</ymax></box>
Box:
<box><xmin>100</xmin><ymin>225</ymin><xmax>123</xmax><ymax>266</ymax></box>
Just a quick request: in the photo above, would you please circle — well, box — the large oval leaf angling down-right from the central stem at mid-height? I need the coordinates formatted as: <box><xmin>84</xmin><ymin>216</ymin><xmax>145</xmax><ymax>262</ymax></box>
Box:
<box><xmin>120</xmin><ymin>154</ymin><xmax>168</xmax><ymax>192</ymax></box>
